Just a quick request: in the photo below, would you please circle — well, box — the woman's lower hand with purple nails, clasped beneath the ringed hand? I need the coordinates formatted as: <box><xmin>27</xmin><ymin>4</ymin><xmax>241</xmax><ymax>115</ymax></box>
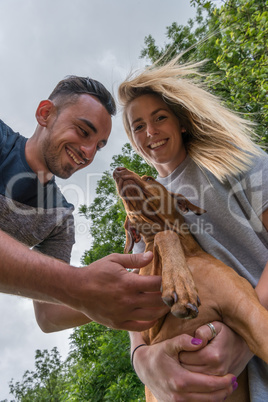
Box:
<box><xmin>133</xmin><ymin>335</ymin><xmax>237</xmax><ymax>402</ymax></box>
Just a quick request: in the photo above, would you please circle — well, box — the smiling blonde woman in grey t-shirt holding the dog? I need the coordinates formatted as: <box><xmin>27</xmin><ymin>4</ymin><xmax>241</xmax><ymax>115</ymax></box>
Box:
<box><xmin>119</xmin><ymin>58</ymin><xmax>268</xmax><ymax>402</ymax></box>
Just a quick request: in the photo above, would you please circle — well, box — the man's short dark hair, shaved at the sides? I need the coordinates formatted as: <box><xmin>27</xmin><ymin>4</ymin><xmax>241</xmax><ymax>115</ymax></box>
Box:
<box><xmin>48</xmin><ymin>75</ymin><xmax>116</xmax><ymax>116</ymax></box>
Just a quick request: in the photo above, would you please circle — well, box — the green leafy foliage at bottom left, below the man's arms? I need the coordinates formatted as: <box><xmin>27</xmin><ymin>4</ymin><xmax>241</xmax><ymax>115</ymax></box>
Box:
<box><xmin>10</xmin><ymin>323</ymin><xmax>144</xmax><ymax>402</ymax></box>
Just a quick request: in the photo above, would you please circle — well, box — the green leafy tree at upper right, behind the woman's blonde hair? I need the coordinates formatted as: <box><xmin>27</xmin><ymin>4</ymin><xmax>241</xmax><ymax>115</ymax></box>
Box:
<box><xmin>141</xmin><ymin>0</ymin><xmax>268</xmax><ymax>145</ymax></box>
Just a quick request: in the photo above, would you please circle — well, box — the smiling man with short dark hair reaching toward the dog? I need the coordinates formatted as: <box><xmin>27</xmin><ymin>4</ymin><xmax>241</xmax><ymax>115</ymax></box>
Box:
<box><xmin>0</xmin><ymin>76</ymin><xmax>166</xmax><ymax>332</ymax></box>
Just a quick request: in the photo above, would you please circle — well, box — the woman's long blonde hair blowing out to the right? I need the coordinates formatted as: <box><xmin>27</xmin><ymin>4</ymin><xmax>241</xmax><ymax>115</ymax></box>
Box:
<box><xmin>118</xmin><ymin>56</ymin><xmax>261</xmax><ymax>181</ymax></box>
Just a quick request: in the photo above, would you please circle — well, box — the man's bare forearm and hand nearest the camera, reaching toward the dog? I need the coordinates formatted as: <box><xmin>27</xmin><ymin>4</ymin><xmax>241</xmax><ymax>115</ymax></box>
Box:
<box><xmin>0</xmin><ymin>231</ymin><xmax>167</xmax><ymax>331</ymax></box>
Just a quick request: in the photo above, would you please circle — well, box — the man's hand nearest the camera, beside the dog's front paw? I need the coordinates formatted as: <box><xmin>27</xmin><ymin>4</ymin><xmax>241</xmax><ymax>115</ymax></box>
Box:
<box><xmin>69</xmin><ymin>252</ymin><xmax>169</xmax><ymax>331</ymax></box>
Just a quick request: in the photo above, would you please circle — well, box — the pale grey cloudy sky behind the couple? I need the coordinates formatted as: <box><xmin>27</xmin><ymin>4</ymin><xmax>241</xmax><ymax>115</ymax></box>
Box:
<box><xmin>0</xmin><ymin>0</ymin><xmax>195</xmax><ymax>401</ymax></box>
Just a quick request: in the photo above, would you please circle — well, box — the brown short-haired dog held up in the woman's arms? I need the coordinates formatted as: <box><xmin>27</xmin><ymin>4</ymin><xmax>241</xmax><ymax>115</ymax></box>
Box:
<box><xmin>114</xmin><ymin>168</ymin><xmax>268</xmax><ymax>402</ymax></box>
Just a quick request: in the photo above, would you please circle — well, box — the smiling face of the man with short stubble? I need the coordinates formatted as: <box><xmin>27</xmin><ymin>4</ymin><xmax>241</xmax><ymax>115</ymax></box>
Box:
<box><xmin>42</xmin><ymin>94</ymin><xmax>112</xmax><ymax>179</ymax></box>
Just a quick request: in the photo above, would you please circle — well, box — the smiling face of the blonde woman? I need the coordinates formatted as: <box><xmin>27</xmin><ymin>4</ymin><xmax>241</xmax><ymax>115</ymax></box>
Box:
<box><xmin>126</xmin><ymin>94</ymin><xmax>186</xmax><ymax>177</ymax></box>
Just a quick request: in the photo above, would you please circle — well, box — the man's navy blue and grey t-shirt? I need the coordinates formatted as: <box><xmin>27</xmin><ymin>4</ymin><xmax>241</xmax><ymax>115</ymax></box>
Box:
<box><xmin>0</xmin><ymin>120</ymin><xmax>74</xmax><ymax>262</ymax></box>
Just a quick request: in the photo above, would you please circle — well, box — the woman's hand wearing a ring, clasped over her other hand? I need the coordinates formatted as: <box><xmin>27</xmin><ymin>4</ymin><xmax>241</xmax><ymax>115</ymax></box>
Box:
<box><xmin>179</xmin><ymin>321</ymin><xmax>253</xmax><ymax>376</ymax></box>
